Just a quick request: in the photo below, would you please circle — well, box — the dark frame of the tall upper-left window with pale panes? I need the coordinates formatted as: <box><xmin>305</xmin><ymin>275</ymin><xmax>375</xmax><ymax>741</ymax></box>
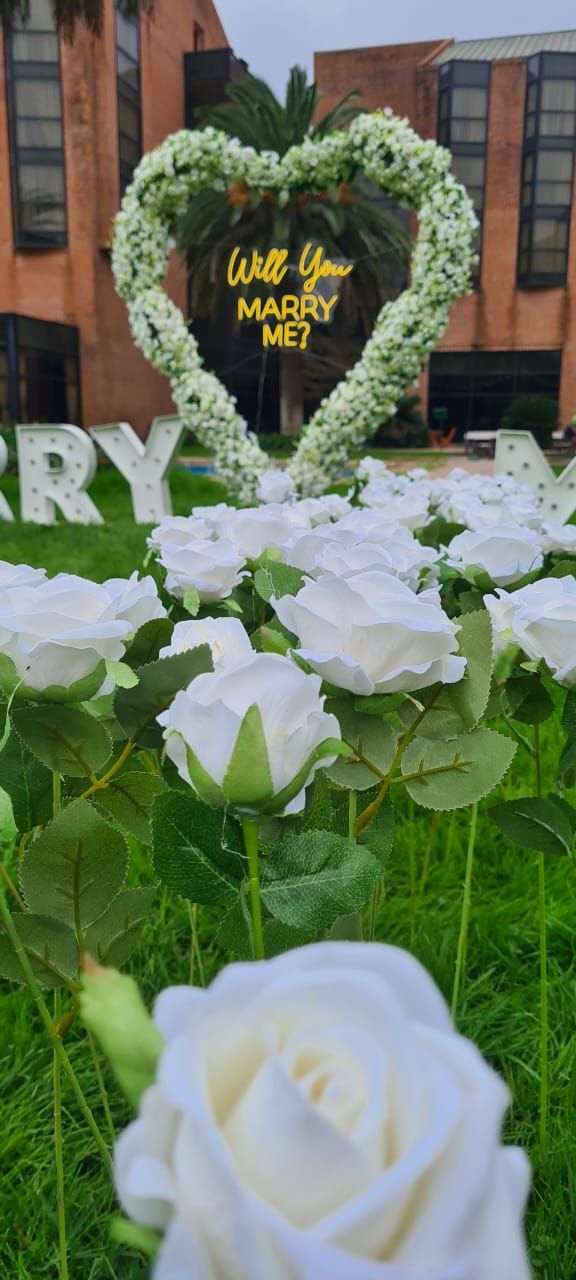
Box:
<box><xmin>4</xmin><ymin>0</ymin><xmax>68</xmax><ymax>251</ymax></box>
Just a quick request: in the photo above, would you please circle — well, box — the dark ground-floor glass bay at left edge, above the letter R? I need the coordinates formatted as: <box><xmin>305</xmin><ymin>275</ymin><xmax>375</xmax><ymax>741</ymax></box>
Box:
<box><xmin>0</xmin><ymin>315</ymin><xmax>82</xmax><ymax>425</ymax></box>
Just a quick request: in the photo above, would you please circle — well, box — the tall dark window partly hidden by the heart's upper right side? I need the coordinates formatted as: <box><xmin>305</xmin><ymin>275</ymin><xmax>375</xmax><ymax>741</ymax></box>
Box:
<box><xmin>438</xmin><ymin>61</ymin><xmax>490</xmax><ymax>278</ymax></box>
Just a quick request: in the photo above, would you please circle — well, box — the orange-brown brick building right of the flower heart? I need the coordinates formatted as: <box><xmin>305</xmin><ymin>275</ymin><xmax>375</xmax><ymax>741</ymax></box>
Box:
<box><xmin>315</xmin><ymin>31</ymin><xmax>576</xmax><ymax>431</ymax></box>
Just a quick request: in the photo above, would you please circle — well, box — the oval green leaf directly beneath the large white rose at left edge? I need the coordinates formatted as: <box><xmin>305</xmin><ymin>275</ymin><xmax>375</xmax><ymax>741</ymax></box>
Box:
<box><xmin>12</xmin><ymin>705</ymin><xmax>113</xmax><ymax>778</ymax></box>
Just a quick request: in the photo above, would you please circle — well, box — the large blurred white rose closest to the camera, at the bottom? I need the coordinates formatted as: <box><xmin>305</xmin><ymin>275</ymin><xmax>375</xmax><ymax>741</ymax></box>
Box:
<box><xmin>115</xmin><ymin>942</ymin><xmax>530</xmax><ymax>1280</ymax></box>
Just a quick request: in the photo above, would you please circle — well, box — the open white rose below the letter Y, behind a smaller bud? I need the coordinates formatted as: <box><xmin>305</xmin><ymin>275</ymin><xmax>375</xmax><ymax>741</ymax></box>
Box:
<box><xmin>159</xmin><ymin>538</ymin><xmax>246</xmax><ymax>604</ymax></box>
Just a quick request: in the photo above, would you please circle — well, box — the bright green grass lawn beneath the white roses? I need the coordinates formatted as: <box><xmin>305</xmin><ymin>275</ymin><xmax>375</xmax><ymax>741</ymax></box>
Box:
<box><xmin>0</xmin><ymin>471</ymin><xmax>576</xmax><ymax>1280</ymax></box>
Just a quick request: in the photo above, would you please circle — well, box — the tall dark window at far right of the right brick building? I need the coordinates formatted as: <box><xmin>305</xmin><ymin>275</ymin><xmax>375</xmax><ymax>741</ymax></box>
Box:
<box><xmin>518</xmin><ymin>54</ymin><xmax>576</xmax><ymax>288</ymax></box>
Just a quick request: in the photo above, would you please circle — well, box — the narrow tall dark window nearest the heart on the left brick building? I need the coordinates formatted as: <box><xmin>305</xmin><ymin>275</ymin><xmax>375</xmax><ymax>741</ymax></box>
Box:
<box><xmin>116</xmin><ymin>0</ymin><xmax>142</xmax><ymax>196</ymax></box>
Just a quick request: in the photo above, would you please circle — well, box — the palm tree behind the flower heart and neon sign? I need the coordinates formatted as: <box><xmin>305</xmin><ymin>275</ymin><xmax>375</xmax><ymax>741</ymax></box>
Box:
<box><xmin>178</xmin><ymin>67</ymin><xmax>410</xmax><ymax>434</ymax></box>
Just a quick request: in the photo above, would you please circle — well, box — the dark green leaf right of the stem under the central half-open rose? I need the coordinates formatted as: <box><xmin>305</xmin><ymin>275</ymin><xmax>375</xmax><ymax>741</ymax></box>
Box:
<box><xmin>261</xmin><ymin>831</ymin><xmax>380</xmax><ymax>933</ymax></box>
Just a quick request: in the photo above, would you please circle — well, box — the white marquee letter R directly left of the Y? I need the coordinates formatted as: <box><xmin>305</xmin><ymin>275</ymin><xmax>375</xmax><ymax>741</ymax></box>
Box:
<box><xmin>15</xmin><ymin>422</ymin><xmax>102</xmax><ymax>525</ymax></box>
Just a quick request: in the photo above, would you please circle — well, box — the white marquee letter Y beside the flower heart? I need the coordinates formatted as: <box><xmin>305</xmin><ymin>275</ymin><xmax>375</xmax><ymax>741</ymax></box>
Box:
<box><xmin>90</xmin><ymin>417</ymin><xmax>184</xmax><ymax>525</ymax></box>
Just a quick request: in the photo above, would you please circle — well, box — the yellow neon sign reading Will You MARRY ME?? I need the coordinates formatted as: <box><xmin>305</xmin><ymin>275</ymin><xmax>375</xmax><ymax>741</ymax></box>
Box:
<box><xmin>228</xmin><ymin>241</ymin><xmax>353</xmax><ymax>351</ymax></box>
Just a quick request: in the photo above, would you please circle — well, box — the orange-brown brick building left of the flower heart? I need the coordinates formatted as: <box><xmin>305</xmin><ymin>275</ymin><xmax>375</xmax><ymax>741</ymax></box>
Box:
<box><xmin>0</xmin><ymin>0</ymin><xmax>232</xmax><ymax>430</ymax></box>
